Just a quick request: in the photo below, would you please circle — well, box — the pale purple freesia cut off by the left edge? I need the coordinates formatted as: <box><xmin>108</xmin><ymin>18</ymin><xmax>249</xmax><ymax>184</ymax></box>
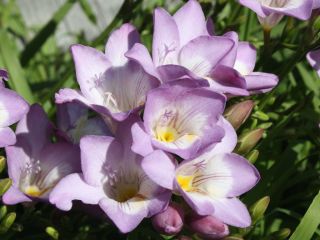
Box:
<box><xmin>0</xmin><ymin>70</ymin><xmax>29</xmax><ymax>148</ymax></box>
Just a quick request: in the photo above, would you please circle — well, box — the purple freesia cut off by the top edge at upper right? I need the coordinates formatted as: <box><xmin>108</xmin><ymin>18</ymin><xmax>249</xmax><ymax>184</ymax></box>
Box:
<box><xmin>239</xmin><ymin>0</ymin><xmax>314</xmax><ymax>29</ymax></box>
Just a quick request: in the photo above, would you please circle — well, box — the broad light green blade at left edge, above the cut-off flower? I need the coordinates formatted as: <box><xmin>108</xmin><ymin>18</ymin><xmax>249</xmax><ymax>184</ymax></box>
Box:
<box><xmin>0</xmin><ymin>30</ymin><xmax>34</xmax><ymax>103</ymax></box>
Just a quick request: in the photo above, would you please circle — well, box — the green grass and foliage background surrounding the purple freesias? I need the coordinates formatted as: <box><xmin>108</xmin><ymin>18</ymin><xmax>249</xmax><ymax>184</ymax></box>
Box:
<box><xmin>0</xmin><ymin>0</ymin><xmax>320</xmax><ymax>240</ymax></box>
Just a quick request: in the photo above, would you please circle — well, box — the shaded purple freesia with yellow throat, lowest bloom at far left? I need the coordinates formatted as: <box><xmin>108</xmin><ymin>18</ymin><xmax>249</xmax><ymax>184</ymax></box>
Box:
<box><xmin>2</xmin><ymin>105</ymin><xmax>80</xmax><ymax>204</ymax></box>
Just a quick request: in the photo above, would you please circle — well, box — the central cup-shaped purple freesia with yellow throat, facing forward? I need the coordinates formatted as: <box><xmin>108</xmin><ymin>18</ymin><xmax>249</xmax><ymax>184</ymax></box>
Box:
<box><xmin>132</xmin><ymin>82</ymin><xmax>225</xmax><ymax>159</ymax></box>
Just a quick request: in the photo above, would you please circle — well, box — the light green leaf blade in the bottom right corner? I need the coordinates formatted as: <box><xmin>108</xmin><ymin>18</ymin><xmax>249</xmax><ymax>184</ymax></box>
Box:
<box><xmin>289</xmin><ymin>192</ymin><xmax>320</xmax><ymax>240</ymax></box>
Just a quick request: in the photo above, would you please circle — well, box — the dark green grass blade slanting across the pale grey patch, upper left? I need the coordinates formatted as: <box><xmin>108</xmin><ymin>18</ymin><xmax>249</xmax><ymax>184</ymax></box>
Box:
<box><xmin>20</xmin><ymin>0</ymin><xmax>76</xmax><ymax>66</ymax></box>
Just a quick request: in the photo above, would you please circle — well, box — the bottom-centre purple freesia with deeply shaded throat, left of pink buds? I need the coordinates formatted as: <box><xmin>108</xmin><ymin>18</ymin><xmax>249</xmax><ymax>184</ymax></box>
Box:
<box><xmin>50</xmin><ymin>117</ymin><xmax>171</xmax><ymax>233</ymax></box>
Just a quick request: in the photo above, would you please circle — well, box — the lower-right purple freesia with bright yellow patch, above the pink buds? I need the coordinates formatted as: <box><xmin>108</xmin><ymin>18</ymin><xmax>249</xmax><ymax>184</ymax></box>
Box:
<box><xmin>142</xmin><ymin>150</ymin><xmax>259</xmax><ymax>227</ymax></box>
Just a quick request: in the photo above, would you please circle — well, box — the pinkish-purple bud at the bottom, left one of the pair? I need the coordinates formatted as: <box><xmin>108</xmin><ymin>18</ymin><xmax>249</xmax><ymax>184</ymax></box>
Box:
<box><xmin>152</xmin><ymin>203</ymin><xmax>184</xmax><ymax>235</ymax></box>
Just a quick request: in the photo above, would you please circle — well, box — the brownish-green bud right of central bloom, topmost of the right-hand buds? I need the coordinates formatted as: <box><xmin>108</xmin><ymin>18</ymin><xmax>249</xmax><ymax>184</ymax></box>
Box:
<box><xmin>224</xmin><ymin>100</ymin><xmax>254</xmax><ymax>129</ymax></box>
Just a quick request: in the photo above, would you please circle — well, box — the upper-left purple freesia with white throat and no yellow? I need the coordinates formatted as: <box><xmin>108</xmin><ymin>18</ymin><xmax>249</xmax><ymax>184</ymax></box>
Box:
<box><xmin>56</xmin><ymin>24</ymin><xmax>159</xmax><ymax>121</ymax></box>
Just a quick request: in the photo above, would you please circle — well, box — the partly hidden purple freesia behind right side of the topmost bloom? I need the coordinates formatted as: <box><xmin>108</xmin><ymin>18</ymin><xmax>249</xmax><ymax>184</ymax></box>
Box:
<box><xmin>216</xmin><ymin>32</ymin><xmax>279</xmax><ymax>93</ymax></box>
